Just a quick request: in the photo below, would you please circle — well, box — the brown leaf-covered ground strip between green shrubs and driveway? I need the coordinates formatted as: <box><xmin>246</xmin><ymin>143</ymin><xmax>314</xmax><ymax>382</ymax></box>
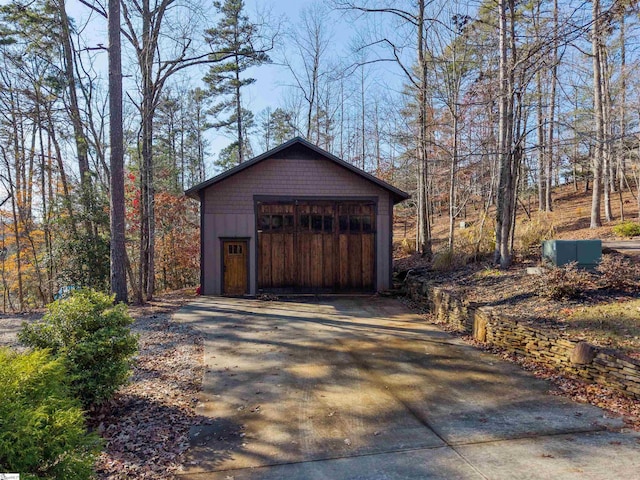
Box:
<box><xmin>90</xmin><ymin>293</ymin><xmax>204</xmax><ymax>480</ymax></box>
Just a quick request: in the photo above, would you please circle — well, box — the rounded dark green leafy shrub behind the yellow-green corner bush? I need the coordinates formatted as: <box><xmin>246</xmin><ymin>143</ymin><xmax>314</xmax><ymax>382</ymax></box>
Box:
<box><xmin>19</xmin><ymin>289</ymin><xmax>138</xmax><ymax>407</ymax></box>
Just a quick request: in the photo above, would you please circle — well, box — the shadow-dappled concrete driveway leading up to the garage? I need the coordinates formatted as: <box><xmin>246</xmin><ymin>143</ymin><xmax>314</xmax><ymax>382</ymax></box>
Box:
<box><xmin>175</xmin><ymin>297</ymin><xmax>640</xmax><ymax>480</ymax></box>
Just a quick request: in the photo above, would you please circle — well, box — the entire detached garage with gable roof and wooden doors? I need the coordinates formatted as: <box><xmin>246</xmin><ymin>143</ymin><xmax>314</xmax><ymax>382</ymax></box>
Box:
<box><xmin>186</xmin><ymin>137</ymin><xmax>408</xmax><ymax>295</ymax></box>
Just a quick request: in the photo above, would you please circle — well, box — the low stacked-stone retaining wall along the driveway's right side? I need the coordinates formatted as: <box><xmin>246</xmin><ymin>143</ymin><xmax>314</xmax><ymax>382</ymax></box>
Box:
<box><xmin>406</xmin><ymin>277</ymin><xmax>640</xmax><ymax>399</ymax></box>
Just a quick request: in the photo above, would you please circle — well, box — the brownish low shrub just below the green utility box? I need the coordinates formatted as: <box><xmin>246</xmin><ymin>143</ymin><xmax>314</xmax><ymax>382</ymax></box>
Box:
<box><xmin>534</xmin><ymin>262</ymin><xmax>593</xmax><ymax>300</ymax></box>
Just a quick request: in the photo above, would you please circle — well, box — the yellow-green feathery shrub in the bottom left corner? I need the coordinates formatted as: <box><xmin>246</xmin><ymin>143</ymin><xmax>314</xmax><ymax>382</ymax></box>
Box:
<box><xmin>0</xmin><ymin>348</ymin><xmax>100</xmax><ymax>480</ymax></box>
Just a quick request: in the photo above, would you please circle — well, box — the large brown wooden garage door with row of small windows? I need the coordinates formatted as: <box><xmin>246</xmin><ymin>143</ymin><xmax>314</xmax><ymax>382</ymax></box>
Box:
<box><xmin>257</xmin><ymin>201</ymin><xmax>376</xmax><ymax>292</ymax></box>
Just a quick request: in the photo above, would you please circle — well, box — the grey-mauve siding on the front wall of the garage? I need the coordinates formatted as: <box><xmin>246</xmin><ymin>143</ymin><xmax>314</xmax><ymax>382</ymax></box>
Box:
<box><xmin>201</xmin><ymin>157</ymin><xmax>393</xmax><ymax>295</ymax></box>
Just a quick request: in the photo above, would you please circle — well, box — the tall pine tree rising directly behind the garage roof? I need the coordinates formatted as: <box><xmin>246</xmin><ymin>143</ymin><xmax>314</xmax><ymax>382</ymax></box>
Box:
<box><xmin>204</xmin><ymin>0</ymin><xmax>269</xmax><ymax>163</ymax></box>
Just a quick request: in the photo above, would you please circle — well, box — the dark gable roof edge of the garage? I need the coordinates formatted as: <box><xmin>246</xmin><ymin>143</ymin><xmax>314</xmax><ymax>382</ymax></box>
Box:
<box><xmin>184</xmin><ymin>137</ymin><xmax>409</xmax><ymax>204</ymax></box>
